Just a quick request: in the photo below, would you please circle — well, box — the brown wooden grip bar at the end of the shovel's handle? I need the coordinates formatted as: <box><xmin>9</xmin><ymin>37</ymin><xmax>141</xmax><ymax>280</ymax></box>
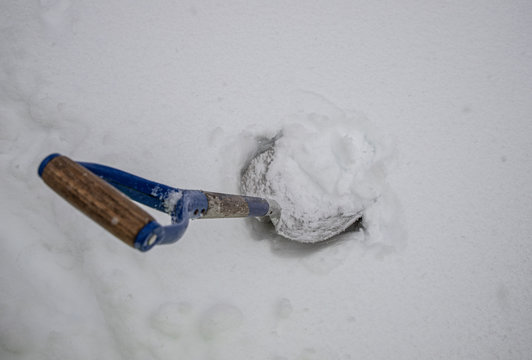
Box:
<box><xmin>40</xmin><ymin>155</ymin><xmax>155</xmax><ymax>247</ymax></box>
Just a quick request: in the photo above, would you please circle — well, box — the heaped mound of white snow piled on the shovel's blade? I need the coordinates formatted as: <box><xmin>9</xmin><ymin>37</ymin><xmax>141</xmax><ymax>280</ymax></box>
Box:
<box><xmin>242</xmin><ymin>106</ymin><xmax>390</xmax><ymax>242</ymax></box>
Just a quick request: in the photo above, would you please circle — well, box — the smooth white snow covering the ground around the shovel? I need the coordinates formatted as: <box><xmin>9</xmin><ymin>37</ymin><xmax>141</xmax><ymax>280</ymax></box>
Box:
<box><xmin>0</xmin><ymin>0</ymin><xmax>532</xmax><ymax>360</ymax></box>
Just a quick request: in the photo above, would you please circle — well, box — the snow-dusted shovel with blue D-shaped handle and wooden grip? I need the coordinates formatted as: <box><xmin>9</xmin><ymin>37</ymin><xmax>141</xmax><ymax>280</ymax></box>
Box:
<box><xmin>38</xmin><ymin>150</ymin><xmax>360</xmax><ymax>251</ymax></box>
